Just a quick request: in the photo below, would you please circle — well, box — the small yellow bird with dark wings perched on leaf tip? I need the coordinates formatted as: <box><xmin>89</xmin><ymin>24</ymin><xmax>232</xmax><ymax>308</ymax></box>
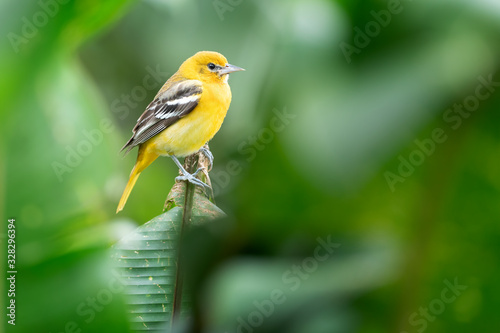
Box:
<box><xmin>116</xmin><ymin>51</ymin><xmax>244</xmax><ymax>213</ymax></box>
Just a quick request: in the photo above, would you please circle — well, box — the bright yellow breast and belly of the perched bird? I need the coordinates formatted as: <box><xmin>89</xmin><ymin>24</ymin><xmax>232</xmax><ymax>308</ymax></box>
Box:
<box><xmin>146</xmin><ymin>83</ymin><xmax>231</xmax><ymax>157</ymax></box>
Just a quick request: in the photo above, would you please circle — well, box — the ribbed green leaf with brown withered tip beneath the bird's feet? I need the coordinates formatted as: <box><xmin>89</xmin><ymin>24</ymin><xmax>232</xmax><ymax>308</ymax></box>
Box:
<box><xmin>112</xmin><ymin>175</ymin><xmax>225</xmax><ymax>331</ymax></box>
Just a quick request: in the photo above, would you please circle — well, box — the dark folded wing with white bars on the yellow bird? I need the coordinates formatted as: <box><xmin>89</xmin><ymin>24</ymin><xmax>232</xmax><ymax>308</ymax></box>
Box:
<box><xmin>121</xmin><ymin>80</ymin><xmax>203</xmax><ymax>153</ymax></box>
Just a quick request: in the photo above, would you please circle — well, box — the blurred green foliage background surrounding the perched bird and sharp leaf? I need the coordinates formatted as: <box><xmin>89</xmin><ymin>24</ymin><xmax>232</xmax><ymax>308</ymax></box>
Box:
<box><xmin>0</xmin><ymin>0</ymin><xmax>500</xmax><ymax>333</ymax></box>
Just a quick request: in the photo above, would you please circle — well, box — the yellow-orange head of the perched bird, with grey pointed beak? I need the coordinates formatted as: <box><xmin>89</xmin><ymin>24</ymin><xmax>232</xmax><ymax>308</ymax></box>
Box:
<box><xmin>179</xmin><ymin>51</ymin><xmax>244</xmax><ymax>83</ymax></box>
